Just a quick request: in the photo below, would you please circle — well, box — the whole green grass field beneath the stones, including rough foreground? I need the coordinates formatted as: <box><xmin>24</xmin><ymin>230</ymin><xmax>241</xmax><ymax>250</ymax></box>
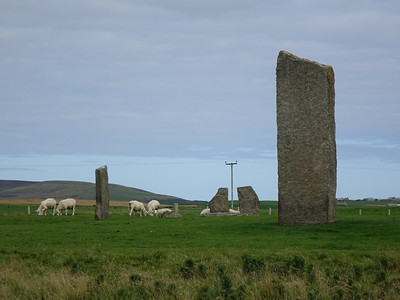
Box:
<box><xmin>0</xmin><ymin>202</ymin><xmax>400</xmax><ymax>299</ymax></box>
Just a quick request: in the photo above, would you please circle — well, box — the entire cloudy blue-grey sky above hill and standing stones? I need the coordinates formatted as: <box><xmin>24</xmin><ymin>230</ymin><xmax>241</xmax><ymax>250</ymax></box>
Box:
<box><xmin>0</xmin><ymin>0</ymin><xmax>400</xmax><ymax>201</ymax></box>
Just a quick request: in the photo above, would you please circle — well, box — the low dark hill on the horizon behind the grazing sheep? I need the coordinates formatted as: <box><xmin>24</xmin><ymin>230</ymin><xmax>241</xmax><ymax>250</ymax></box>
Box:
<box><xmin>0</xmin><ymin>180</ymin><xmax>203</xmax><ymax>204</ymax></box>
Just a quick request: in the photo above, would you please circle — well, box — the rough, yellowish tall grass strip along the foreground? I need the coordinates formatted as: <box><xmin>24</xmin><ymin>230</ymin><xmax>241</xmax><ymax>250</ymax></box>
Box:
<box><xmin>0</xmin><ymin>251</ymin><xmax>400</xmax><ymax>299</ymax></box>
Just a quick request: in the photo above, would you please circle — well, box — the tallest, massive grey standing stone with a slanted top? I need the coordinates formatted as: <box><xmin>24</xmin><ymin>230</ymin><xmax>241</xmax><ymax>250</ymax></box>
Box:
<box><xmin>276</xmin><ymin>51</ymin><xmax>336</xmax><ymax>225</ymax></box>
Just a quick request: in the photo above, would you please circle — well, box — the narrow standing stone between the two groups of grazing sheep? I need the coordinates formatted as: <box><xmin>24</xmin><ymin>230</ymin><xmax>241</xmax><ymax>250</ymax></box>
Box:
<box><xmin>95</xmin><ymin>166</ymin><xmax>110</xmax><ymax>220</ymax></box>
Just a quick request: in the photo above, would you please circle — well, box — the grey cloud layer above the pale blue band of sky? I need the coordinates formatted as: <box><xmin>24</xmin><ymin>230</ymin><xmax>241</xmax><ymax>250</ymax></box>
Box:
<box><xmin>0</xmin><ymin>0</ymin><xmax>400</xmax><ymax>164</ymax></box>
